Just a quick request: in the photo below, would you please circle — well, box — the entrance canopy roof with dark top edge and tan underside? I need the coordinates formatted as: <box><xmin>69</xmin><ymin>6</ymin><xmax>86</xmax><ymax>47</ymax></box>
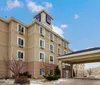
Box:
<box><xmin>57</xmin><ymin>47</ymin><xmax>100</xmax><ymax>64</ymax></box>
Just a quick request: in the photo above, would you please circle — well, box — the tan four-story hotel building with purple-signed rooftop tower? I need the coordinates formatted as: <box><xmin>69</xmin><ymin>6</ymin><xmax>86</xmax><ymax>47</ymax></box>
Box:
<box><xmin>0</xmin><ymin>10</ymin><xmax>84</xmax><ymax>78</ymax></box>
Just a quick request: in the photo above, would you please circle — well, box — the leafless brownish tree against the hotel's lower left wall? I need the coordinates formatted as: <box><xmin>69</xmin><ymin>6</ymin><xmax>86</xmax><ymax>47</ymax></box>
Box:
<box><xmin>3</xmin><ymin>57</ymin><xmax>26</xmax><ymax>79</ymax></box>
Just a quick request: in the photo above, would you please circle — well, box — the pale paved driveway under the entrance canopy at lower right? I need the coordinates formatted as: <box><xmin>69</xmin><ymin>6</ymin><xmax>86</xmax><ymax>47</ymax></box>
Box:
<box><xmin>56</xmin><ymin>79</ymin><xmax>100</xmax><ymax>85</ymax></box>
